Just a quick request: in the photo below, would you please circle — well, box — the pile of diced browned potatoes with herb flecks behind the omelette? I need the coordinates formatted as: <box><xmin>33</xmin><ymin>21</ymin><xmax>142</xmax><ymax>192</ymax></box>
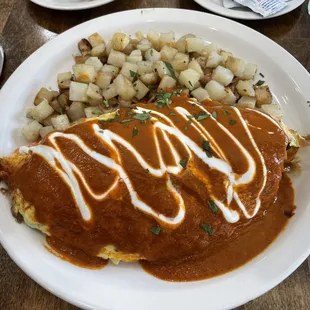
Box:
<box><xmin>22</xmin><ymin>30</ymin><xmax>280</xmax><ymax>142</ymax></box>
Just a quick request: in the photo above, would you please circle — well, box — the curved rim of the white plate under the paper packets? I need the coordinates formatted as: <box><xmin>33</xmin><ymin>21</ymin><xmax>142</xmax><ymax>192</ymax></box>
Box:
<box><xmin>194</xmin><ymin>0</ymin><xmax>306</xmax><ymax>20</ymax></box>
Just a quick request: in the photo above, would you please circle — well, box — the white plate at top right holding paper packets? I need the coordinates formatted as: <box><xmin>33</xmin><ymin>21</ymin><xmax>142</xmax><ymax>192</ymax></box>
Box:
<box><xmin>194</xmin><ymin>0</ymin><xmax>305</xmax><ymax>19</ymax></box>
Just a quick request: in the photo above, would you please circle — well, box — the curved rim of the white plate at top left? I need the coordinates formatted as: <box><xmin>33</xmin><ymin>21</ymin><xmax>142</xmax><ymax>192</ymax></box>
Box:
<box><xmin>30</xmin><ymin>0</ymin><xmax>115</xmax><ymax>10</ymax></box>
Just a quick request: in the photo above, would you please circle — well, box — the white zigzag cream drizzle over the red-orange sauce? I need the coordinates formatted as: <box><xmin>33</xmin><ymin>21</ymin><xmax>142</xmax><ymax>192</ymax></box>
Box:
<box><xmin>20</xmin><ymin>105</ymin><xmax>279</xmax><ymax>226</ymax></box>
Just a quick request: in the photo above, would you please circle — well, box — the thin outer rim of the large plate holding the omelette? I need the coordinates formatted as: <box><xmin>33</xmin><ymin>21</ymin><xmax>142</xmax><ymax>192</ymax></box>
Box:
<box><xmin>0</xmin><ymin>8</ymin><xmax>310</xmax><ymax>309</ymax></box>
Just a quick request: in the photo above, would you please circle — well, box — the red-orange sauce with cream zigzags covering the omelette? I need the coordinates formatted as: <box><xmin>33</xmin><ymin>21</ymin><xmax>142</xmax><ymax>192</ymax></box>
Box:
<box><xmin>9</xmin><ymin>97</ymin><xmax>295</xmax><ymax>281</ymax></box>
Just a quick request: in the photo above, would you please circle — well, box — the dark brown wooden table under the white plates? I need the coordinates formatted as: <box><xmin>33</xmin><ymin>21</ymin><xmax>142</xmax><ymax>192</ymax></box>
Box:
<box><xmin>0</xmin><ymin>0</ymin><xmax>310</xmax><ymax>310</ymax></box>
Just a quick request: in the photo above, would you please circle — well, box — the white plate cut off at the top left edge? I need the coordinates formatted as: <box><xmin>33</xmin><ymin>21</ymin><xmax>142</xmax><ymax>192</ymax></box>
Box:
<box><xmin>31</xmin><ymin>0</ymin><xmax>114</xmax><ymax>11</ymax></box>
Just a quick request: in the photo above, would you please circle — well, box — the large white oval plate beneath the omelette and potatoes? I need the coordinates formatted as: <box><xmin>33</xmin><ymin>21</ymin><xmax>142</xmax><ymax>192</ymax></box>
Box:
<box><xmin>0</xmin><ymin>9</ymin><xmax>310</xmax><ymax>310</ymax></box>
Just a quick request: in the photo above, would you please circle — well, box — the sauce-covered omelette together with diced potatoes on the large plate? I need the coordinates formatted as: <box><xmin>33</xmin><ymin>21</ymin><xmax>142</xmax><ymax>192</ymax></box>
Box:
<box><xmin>0</xmin><ymin>31</ymin><xmax>306</xmax><ymax>281</ymax></box>
